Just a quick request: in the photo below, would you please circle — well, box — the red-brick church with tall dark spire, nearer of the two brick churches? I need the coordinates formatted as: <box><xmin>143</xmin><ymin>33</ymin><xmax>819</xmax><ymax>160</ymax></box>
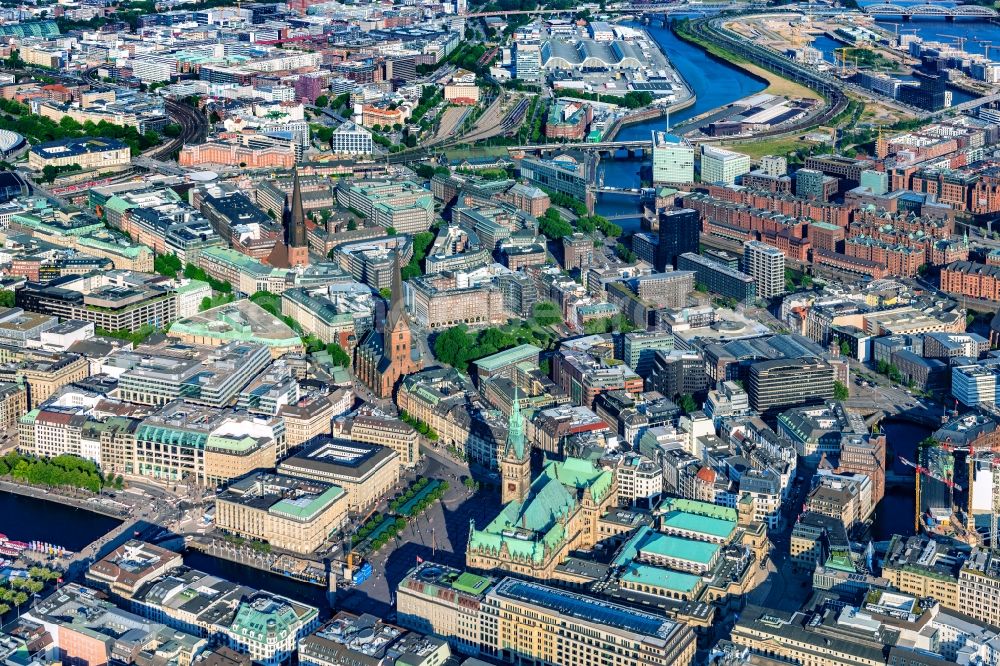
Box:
<box><xmin>354</xmin><ymin>250</ymin><xmax>423</xmax><ymax>398</ymax></box>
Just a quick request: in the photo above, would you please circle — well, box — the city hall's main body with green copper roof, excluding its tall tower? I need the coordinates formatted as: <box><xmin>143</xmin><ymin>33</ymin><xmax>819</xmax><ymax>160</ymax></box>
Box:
<box><xmin>466</xmin><ymin>458</ymin><xmax>618</xmax><ymax>579</ymax></box>
